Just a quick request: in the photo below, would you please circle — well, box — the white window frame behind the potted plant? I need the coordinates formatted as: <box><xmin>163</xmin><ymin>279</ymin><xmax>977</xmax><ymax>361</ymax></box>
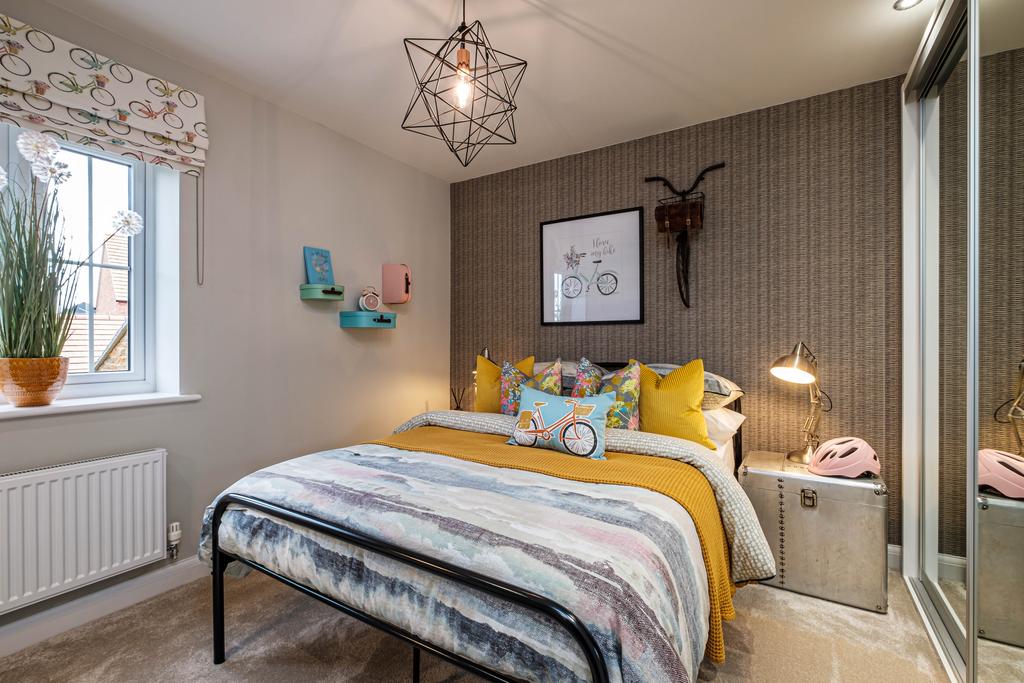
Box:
<box><xmin>0</xmin><ymin>125</ymin><xmax>157</xmax><ymax>398</ymax></box>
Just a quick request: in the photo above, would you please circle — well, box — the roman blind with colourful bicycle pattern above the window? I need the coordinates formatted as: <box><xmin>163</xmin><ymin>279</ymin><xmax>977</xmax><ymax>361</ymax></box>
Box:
<box><xmin>0</xmin><ymin>14</ymin><xmax>209</xmax><ymax>175</ymax></box>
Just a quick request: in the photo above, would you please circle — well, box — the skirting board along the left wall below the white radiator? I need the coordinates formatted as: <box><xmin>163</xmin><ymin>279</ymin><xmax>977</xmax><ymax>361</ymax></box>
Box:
<box><xmin>0</xmin><ymin>556</ymin><xmax>210</xmax><ymax>657</ymax></box>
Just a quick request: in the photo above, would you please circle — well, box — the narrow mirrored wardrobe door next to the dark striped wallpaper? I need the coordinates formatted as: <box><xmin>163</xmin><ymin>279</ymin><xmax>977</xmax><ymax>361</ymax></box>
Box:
<box><xmin>921</xmin><ymin>13</ymin><xmax>970</xmax><ymax>663</ymax></box>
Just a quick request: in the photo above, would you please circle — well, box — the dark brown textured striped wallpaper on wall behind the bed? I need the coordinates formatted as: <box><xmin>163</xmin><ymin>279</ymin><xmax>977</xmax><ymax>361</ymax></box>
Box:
<box><xmin>452</xmin><ymin>78</ymin><xmax>901</xmax><ymax>543</ymax></box>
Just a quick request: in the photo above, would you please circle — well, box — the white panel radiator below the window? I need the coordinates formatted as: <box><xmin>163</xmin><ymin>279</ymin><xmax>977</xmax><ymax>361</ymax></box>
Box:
<box><xmin>0</xmin><ymin>449</ymin><xmax>167</xmax><ymax>614</ymax></box>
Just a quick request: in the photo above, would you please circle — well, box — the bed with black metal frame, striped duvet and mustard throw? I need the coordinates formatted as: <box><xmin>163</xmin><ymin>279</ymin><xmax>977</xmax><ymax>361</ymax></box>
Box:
<box><xmin>200</xmin><ymin>411</ymin><xmax>775</xmax><ymax>681</ymax></box>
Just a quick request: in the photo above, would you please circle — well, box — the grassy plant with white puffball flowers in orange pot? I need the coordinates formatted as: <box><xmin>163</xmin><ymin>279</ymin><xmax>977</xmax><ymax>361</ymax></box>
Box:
<box><xmin>0</xmin><ymin>131</ymin><xmax>142</xmax><ymax>407</ymax></box>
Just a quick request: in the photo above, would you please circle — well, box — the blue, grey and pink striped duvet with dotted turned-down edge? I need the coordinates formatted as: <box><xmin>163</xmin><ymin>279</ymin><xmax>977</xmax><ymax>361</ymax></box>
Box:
<box><xmin>200</xmin><ymin>412</ymin><xmax>774</xmax><ymax>681</ymax></box>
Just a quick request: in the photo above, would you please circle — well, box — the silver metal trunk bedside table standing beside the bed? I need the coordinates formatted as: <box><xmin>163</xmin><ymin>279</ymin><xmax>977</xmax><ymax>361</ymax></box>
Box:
<box><xmin>739</xmin><ymin>451</ymin><xmax>889</xmax><ymax>612</ymax></box>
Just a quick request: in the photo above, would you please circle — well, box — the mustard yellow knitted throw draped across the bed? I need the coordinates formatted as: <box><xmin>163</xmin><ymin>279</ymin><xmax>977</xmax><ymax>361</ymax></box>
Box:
<box><xmin>375</xmin><ymin>426</ymin><xmax>736</xmax><ymax>663</ymax></box>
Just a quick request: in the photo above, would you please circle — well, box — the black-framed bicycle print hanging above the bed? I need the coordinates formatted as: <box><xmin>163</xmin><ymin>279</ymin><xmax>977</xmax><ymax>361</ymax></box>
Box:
<box><xmin>541</xmin><ymin>207</ymin><xmax>643</xmax><ymax>325</ymax></box>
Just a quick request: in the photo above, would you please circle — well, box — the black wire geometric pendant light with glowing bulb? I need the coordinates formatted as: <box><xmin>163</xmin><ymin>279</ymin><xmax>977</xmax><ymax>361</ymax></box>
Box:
<box><xmin>401</xmin><ymin>0</ymin><xmax>526</xmax><ymax>166</ymax></box>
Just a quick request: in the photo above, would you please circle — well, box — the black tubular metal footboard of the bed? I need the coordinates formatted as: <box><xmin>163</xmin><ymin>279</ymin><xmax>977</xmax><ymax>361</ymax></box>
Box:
<box><xmin>210</xmin><ymin>494</ymin><xmax>608</xmax><ymax>683</ymax></box>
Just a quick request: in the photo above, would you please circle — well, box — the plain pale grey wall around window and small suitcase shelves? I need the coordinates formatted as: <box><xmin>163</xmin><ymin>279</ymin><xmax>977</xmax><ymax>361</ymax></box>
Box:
<box><xmin>0</xmin><ymin>0</ymin><xmax>455</xmax><ymax>621</ymax></box>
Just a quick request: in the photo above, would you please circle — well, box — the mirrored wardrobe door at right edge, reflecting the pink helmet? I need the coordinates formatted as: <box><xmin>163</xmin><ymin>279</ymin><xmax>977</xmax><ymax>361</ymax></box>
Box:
<box><xmin>974</xmin><ymin>0</ymin><xmax>1024</xmax><ymax>683</ymax></box>
